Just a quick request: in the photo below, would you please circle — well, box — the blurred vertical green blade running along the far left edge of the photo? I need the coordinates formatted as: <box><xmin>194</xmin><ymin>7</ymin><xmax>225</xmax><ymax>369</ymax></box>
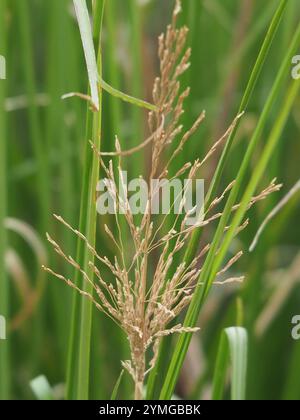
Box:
<box><xmin>0</xmin><ymin>0</ymin><xmax>10</xmax><ymax>400</ymax></box>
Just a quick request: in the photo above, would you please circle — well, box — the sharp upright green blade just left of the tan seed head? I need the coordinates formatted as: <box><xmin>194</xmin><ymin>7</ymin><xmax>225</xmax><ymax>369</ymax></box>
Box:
<box><xmin>66</xmin><ymin>0</ymin><xmax>105</xmax><ymax>399</ymax></box>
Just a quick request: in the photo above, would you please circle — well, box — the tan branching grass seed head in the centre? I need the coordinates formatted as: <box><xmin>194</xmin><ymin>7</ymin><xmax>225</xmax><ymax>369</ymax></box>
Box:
<box><xmin>45</xmin><ymin>1</ymin><xmax>280</xmax><ymax>399</ymax></box>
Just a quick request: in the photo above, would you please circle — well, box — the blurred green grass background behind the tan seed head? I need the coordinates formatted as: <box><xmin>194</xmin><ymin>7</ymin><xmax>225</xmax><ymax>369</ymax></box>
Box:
<box><xmin>0</xmin><ymin>0</ymin><xmax>300</xmax><ymax>399</ymax></box>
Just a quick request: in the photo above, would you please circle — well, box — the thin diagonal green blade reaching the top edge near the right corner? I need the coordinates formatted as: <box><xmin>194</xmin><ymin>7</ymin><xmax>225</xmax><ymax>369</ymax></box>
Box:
<box><xmin>185</xmin><ymin>0</ymin><xmax>287</xmax><ymax>262</ymax></box>
